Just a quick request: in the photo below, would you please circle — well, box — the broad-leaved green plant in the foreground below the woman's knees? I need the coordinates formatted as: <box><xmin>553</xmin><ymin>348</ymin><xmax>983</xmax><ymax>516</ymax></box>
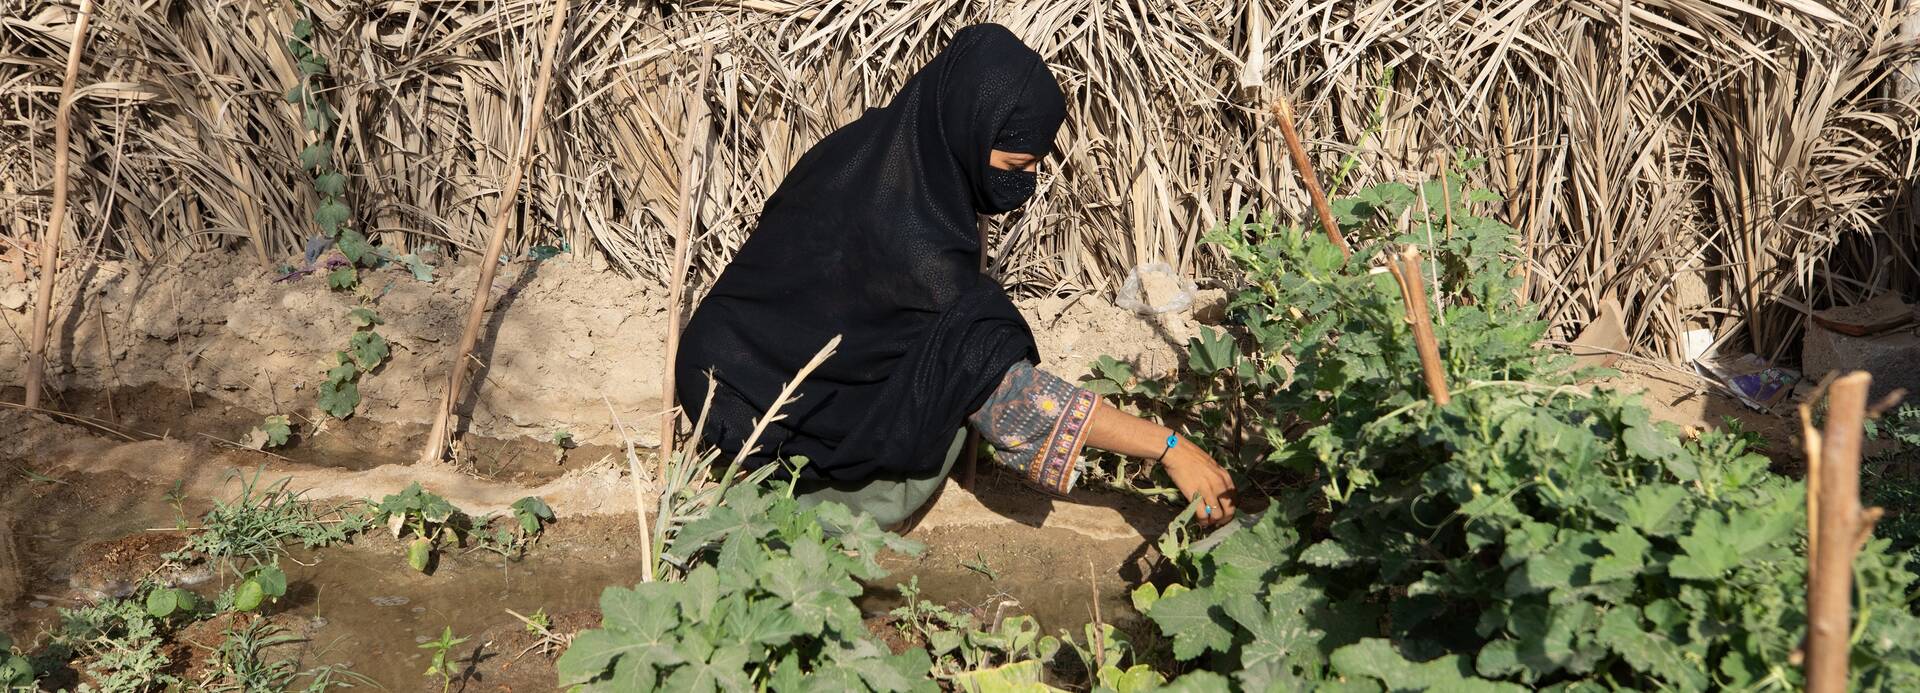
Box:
<box><xmin>555</xmin><ymin>484</ymin><xmax>935</xmax><ymax>691</ymax></box>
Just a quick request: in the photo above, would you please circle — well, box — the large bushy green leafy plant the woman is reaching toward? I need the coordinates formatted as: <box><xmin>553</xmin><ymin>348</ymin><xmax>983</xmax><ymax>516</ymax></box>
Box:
<box><xmin>1140</xmin><ymin>161</ymin><xmax>1920</xmax><ymax>691</ymax></box>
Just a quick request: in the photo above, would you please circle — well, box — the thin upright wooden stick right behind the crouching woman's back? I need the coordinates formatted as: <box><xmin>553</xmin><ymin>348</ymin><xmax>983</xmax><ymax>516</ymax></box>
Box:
<box><xmin>660</xmin><ymin>44</ymin><xmax>714</xmax><ymax>478</ymax></box>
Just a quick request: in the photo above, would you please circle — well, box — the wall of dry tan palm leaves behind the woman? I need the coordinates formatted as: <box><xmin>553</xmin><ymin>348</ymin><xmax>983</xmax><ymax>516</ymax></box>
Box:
<box><xmin>0</xmin><ymin>0</ymin><xmax>1920</xmax><ymax>355</ymax></box>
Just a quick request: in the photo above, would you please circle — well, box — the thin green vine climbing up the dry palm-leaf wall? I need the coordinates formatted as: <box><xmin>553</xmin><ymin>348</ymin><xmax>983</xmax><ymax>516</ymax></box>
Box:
<box><xmin>286</xmin><ymin>19</ymin><xmax>388</xmax><ymax>418</ymax></box>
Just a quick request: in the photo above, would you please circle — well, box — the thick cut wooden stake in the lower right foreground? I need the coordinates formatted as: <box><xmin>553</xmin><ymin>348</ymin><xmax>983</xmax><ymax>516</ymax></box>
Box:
<box><xmin>1807</xmin><ymin>370</ymin><xmax>1878</xmax><ymax>693</ymax></box>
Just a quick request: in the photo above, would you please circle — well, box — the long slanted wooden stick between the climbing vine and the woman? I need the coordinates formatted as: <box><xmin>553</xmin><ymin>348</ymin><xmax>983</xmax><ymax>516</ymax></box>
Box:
<box><xmin>420</xmin><ymin>0</ymin><xmax>566</xmax><ymax>463</ymax></box>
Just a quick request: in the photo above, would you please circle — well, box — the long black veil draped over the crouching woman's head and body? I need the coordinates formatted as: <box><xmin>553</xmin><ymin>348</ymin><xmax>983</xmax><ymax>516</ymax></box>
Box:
<box><xmin>676</xmin><ymin>25</ymin><xmax>1066</xmax><ymax>480</ymax></box>
